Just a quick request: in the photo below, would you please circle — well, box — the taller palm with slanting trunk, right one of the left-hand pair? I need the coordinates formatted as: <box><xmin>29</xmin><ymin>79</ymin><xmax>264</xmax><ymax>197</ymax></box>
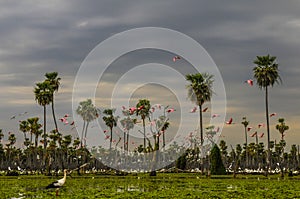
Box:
<box><xmin>45</xmin><ymin>72</ymin><xmax>61</xmax><ymax>131</ymax></box>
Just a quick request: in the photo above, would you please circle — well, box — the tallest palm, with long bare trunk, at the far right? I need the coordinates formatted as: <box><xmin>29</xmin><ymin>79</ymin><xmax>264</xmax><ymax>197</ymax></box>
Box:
<box><xmin>253</xmin><ymin>55</ymin><xmax>281</xmax><ymax>167</ymax></box>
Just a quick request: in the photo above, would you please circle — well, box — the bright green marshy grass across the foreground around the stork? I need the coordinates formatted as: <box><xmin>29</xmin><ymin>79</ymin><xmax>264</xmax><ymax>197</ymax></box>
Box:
<box><xmin>0</xmin><ymin>173</ymin><xmax>300</xmax><ymax>199</ymax></box>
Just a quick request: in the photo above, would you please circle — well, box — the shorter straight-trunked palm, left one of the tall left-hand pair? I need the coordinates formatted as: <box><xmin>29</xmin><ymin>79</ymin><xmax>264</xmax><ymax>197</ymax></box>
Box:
<box><xmin>34</xmin><ymin>81</ymin><xmax>52</xmax><ymax>149</ymax></box>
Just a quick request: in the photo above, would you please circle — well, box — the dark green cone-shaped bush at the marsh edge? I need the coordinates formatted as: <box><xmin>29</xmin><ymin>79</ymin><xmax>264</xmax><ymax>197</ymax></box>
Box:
<box><xmin>210</xmin><ymin>144</ymin><xmax>226</xmax><ymax>175</ymax></box>
